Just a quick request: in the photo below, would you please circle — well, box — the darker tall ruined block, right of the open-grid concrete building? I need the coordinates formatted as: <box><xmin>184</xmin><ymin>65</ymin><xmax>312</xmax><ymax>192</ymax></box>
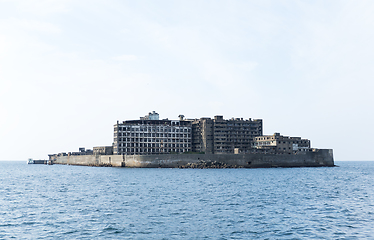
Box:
<box><xmin>192</xmin><ymin>116</ymin><xmax>263</xmax><ymax>154</ymax></box>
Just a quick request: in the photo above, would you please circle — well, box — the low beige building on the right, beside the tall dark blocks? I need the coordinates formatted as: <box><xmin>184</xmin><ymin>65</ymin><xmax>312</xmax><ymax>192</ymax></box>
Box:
<box><xmin>253</xmin><ymin>133</ymin><xmax>310</xmax><ymax>153</ymax></box>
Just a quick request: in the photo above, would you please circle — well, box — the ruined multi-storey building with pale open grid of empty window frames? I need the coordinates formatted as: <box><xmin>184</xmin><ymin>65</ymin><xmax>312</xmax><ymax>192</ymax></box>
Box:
<box><xmin>113</xmin><ymin>112</ymin><xmax>192</xmax><ymax>155</ymax></box>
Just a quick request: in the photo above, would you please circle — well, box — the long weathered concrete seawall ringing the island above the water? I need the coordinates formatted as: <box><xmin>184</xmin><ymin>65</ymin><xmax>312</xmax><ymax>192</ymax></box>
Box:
<box><xmin>54</xmin><ymin>149</ymin><xmax>334</xmax><ymax>168</ymax></box>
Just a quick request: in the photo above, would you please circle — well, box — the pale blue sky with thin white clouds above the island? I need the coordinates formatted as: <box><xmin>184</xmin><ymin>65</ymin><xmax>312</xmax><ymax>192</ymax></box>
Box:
<box><xmin>0</xmin><ymin>0</ymin><xmax>374</xmax><ymax>161</ymax></box>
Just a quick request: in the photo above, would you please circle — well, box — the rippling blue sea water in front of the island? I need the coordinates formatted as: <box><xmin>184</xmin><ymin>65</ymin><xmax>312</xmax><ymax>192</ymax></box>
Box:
<box><xmin>0</xmin><ymin>161</ymin><xmax>374</xmax><ymax>239</ymax></box>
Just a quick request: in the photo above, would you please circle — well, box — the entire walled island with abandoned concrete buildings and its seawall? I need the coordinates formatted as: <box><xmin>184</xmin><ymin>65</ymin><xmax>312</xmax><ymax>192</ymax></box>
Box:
<box><xmin>49</xmin><ymin>111</ymin><xmax>334</xmax><ymax>168</ymax></box>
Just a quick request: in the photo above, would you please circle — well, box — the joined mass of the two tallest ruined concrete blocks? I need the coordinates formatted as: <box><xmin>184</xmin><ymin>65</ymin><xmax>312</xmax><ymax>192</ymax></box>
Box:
<box><xmin>113</xmin><ymin>111</ymin><xmax>262</xmax><ymax>155</ymax></box>
